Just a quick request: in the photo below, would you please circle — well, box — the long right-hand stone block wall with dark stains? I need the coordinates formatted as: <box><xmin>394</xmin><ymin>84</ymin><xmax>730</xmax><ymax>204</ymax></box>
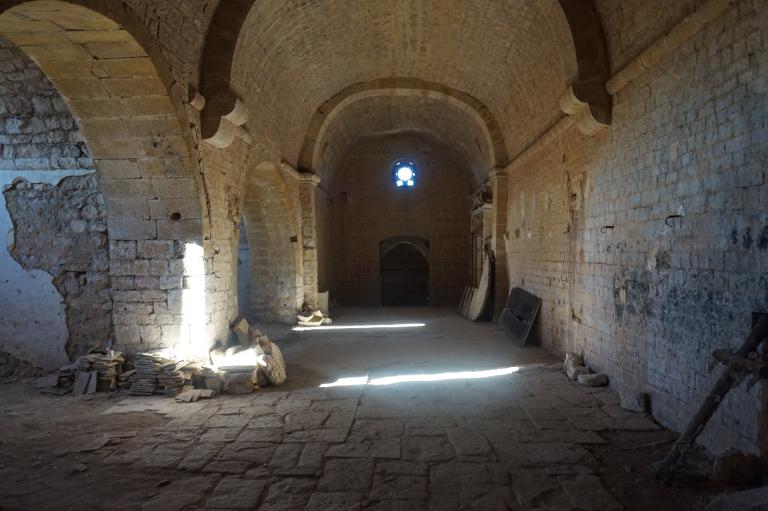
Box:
<box><xmin>507</xmin><ymin>0</ymin><xmax>768</xmax><ymax>451</ymax></box>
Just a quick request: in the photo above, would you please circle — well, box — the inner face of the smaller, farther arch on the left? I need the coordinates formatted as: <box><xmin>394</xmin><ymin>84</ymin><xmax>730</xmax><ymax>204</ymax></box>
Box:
<box><xmin>242</xmin><ymin>161</ymin><xmax>303</xmax><ymax>323</ymax></box>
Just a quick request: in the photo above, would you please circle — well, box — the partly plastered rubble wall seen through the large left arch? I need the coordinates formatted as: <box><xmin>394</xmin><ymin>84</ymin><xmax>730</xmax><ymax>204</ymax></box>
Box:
<box><xmin>0</xmin><ymin>39</ymin><xmax>113</xmax><ymax>372</ymax></box>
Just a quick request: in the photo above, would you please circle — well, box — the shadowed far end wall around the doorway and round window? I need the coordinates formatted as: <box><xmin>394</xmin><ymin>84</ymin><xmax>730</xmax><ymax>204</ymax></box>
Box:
<box><xmin>329</xmin><ymin>134</ymin><xmax>471</xmax><ymax>305</ymax></box>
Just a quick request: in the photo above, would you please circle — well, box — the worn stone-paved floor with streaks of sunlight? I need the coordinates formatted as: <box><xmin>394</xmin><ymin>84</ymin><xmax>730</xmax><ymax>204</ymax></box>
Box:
<box><xmin>0</xmin><ymin>309</ymin><xmax>720</xmax><ymax>511</ymax></box>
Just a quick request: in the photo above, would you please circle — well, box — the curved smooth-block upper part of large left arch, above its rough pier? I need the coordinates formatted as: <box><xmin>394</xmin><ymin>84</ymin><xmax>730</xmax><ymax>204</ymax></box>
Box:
<box><xmin>0</xmin><ymin>1</ymin><xmax>202</xmax><ymax>240</ymax></box>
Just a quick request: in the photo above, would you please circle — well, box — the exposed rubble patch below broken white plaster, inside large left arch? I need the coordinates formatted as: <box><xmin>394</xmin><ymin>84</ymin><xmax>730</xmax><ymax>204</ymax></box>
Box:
<box><xmin>3</xmin><ymin>174</ymin><xmax>113</xmax><ymax>358</ymax></box>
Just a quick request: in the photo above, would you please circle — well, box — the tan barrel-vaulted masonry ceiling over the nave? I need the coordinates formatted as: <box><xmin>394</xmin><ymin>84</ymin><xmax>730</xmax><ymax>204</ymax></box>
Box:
<box><xmin>231</xmin><ymin>0</ymin><xmax>578</xmax><ymax>184</ymax></box>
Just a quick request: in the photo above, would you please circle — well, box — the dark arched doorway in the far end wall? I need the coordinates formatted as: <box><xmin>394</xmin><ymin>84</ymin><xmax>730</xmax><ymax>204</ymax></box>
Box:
<box><xmin>381</xmin><ymin>243</ymin><xmax>429</xmax><ymax>306</ymax></box>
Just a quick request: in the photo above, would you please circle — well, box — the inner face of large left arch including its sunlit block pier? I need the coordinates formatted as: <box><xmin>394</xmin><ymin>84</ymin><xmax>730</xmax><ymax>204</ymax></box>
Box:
<box><xmin>0</xmin><ymin>0</ymin><xmax>208</xmax><ymax>351</ymax></box>
